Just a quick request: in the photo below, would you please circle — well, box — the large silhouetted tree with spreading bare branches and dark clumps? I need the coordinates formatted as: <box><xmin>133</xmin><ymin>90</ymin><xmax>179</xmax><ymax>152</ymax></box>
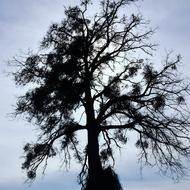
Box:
<box><xmin>12</xmin><ymin>0</ymin><xmax>190</xmax><ymax>190</ymax></box>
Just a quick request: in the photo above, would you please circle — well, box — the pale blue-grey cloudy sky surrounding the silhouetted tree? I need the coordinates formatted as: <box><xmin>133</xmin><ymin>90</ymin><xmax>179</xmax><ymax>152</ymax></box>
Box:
<box><xmin>0</xmin><ymin>0</ymin><xmax>190</xmax><ymax>190</ymax></box>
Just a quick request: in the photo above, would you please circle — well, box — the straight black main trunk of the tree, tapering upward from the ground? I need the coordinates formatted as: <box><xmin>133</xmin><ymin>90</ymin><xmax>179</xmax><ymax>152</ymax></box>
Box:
<box><xmin>85</xmin><ymin>75</ymin><xmax>103</xmax><ymax>190</ymax></box>
